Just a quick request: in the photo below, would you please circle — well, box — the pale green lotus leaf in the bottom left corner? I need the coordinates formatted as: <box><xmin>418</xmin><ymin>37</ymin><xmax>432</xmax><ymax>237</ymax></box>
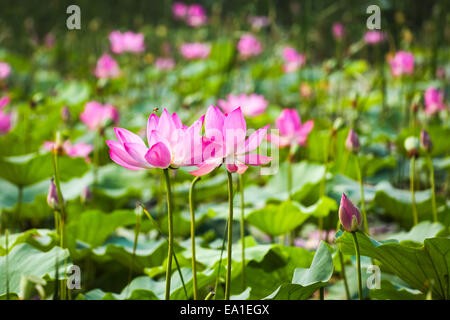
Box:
<box><xmin>0</xmin><ymin>243</ymin><xmax>71</xmax><ymax>296</ymax></box>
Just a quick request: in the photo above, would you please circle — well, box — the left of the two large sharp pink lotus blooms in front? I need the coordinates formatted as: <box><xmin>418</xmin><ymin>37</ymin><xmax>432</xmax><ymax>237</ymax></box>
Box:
<box><xmin>106</xmin><ymin>109</ymin><xmax>205</xmax><ymax>170</ymax></box>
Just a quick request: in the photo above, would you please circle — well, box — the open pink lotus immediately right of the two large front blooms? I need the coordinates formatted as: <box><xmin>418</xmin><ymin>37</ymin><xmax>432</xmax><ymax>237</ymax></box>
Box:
<box><xmin>267</xmin><ymin>109</ymin><xmax>314</xmax><ymax>147</ymax></box>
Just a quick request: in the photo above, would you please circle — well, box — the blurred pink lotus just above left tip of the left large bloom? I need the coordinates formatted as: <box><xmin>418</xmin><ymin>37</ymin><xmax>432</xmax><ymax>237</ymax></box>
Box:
<box><xmin>80</xmin><ymin>101</ymin><xmax>119</xmax><ymax>130</ymax></box>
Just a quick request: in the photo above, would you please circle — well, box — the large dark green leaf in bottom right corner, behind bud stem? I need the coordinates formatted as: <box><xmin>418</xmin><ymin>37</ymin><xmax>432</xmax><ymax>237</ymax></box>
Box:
<box><xmin>336</xmin><ymin>232</ymin><xmax>450</xmax><ymax>299</ymax></box>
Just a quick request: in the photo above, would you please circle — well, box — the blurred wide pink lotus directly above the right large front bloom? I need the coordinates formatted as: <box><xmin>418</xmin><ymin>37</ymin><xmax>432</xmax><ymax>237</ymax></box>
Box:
<box><xmin>218</xmin><ymin>93</ymin><xmax>269</xmax><ymax>117</ymax></box>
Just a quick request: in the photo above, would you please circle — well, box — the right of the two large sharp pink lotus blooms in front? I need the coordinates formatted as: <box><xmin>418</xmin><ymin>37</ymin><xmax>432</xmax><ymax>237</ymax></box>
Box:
<box><xmin>191</xmin><ymin>106</ymin><xmax>272</xmax><ymax>176</ymax></box>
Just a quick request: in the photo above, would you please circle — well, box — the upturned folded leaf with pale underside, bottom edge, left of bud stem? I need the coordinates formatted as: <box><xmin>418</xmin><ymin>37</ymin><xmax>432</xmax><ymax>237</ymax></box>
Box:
<box><xmin>265</xmin><ymin>242</ymin><xmax>333</xmax><ymax>300</ymax></box>
